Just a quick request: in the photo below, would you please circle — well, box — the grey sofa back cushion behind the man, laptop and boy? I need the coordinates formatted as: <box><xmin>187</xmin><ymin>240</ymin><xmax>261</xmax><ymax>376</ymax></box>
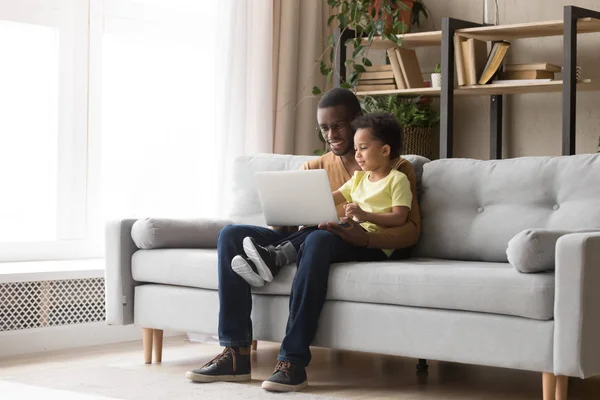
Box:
<box><xmin>228</xmin><ymin>154</ymin><xmax>429</xmax><ymax>226</ymax></box>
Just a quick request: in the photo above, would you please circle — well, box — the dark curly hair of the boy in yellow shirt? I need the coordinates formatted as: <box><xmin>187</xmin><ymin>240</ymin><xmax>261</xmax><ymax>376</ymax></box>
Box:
<box><xmin>352</xmin><ymin>112</ymin><xmax>402</xmax><ymax>159</ymax></box>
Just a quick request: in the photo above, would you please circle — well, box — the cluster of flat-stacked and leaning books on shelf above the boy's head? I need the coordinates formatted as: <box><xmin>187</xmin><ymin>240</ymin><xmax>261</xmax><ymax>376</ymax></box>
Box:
<box><xmin>356</xmin><ymin>47</ymin><xmax>425</xmax><ymax>92</ymax></box>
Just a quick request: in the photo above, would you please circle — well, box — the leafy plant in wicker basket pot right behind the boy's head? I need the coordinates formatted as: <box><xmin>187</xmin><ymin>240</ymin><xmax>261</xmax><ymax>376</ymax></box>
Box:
<box><xmin>361</xmin><ymin>95</ymin><xmax>440</xmax><ymax>159</ymax></box>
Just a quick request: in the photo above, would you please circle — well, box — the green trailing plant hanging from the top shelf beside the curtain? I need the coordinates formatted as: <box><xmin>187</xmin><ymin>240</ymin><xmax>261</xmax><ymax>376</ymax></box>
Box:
<box><xmin>312</xmin><ymin>0</ymin><xmax>429</xmax><ymax>95</ymax></box>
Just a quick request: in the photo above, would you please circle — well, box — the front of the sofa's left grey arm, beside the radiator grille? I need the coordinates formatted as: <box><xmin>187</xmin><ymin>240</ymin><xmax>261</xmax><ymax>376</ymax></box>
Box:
<box><xmin>105</xmin><ymin>219</ymin><xmax>138</xmax><ymax>325</ymax></box>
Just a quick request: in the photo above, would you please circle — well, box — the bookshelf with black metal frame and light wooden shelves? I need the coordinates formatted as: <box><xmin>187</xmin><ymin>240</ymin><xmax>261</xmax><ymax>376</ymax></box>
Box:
<box><xmin>340</xmin><ymin>6</ymin><xmax>600</xmax><ymax>159</ymax></box>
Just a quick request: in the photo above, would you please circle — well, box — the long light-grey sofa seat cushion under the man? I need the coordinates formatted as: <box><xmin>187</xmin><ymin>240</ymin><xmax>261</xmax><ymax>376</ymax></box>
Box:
<box><xmin>132</xmin><ymin>249</ymin><xmax>554</xmax><ymax>320</ymax></box>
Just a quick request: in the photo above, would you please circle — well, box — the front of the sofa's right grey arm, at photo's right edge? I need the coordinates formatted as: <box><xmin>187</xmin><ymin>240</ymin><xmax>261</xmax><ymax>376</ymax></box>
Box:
<box><xmin>554</xmin><ymin>233</ymin><xmax>600</xmax><ymax>378</ymax></box>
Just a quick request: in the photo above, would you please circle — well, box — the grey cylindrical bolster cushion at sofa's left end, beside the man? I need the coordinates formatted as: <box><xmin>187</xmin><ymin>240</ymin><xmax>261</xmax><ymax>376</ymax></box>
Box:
<box><xmin>131</xmin><ymin>218</ymin><xmax>231</xmax><ymax>250</ymax></box>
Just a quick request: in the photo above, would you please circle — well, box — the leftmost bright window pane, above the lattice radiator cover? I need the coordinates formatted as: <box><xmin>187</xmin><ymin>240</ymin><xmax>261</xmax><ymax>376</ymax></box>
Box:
<box><xmin>0</xmin><ymin>0</ymin><xmax>93</xmax><ymax>261</ymax></box>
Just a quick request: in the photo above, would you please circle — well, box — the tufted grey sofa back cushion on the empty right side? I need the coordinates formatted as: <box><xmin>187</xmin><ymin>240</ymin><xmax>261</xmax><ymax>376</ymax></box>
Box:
<box><xmin>417</xmin><ymin>154</ymin><xmax>600</xmax><ymax>262</ymax></box>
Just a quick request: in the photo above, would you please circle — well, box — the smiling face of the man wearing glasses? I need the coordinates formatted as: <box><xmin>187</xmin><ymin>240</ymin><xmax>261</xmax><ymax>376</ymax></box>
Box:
<box><xmin>317</xmin><ymin>105</ymin><xmax>354</xmax><ymax>156</ymax></box>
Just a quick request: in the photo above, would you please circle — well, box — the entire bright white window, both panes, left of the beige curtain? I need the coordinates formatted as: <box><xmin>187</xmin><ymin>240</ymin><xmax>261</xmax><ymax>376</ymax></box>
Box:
<box><xmin>0</xmin><ymin>0</ymin><xmax>225</xmax><ymax>262</ymax></box>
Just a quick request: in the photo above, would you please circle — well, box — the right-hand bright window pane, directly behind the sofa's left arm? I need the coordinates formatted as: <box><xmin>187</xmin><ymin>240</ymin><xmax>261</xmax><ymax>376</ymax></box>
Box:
<box><xmin>99</xmin><ymin>0</ymin><xmax>218</xmax><ymax>219</ymax></box>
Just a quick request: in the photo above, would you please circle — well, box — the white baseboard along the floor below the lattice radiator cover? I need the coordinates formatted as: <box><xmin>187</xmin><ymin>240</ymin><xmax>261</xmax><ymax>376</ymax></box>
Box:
<box><xmin>0</xmin><ymin>322</ymin><xmax>183</xmax><ymax>357</ymax></box>
